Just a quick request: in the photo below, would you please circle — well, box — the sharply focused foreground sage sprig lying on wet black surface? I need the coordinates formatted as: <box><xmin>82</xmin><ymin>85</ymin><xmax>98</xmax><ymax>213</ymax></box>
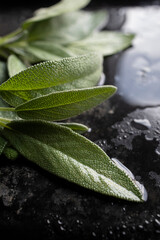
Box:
<box><xmin>0</xmin><ymin>53</ymin><xmax>146</xmax><ymax>201</ymax></box>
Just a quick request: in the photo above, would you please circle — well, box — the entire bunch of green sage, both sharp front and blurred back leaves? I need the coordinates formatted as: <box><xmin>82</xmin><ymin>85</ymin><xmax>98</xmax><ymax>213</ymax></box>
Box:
<box><xmin>0</xmin><ymin>0</ymin><xmax>146</xmax><ymax>202</ymax></box>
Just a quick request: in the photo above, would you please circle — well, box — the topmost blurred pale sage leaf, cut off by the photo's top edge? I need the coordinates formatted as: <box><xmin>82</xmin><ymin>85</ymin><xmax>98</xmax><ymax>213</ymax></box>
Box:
<box><xmin>22</xmin><ymin>0</ymin><xmax>90</xmax><ymax>29</ymax></box>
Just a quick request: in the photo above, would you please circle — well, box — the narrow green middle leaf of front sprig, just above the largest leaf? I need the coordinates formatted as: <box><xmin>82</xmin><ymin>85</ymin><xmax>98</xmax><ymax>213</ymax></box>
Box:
<box><xmin>15</xmin><ymin>85</ymin><xmax>116</xmax><ymax>121</ymax></box>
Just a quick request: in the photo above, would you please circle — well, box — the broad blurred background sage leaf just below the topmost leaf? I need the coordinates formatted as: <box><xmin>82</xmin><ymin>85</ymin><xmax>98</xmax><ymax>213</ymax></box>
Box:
<box><xmin>27</xmin><ymin>10</ymin><xmax>108</xmax><ymax>44</ymax></box>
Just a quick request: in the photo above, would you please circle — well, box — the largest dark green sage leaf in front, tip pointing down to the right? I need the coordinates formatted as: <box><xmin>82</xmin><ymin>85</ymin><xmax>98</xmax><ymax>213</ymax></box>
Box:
<box><xmin>2</xmin><ymin>121</ymin><xmax>146</xmax><ymax>202</ymax></box>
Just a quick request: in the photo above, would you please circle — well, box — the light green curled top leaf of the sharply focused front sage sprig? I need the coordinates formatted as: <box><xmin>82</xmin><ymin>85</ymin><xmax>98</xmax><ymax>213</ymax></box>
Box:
<box><xmin>0</xmin><ymin>53</ymin><xmax>102</xmax><ymax>106</ymax></box>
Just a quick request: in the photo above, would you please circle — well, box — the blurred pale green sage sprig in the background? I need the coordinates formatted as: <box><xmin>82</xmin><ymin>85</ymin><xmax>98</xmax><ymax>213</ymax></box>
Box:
<box><xmin>0</xmin><ymin>0</ymin><xmax>134</xmax><ymax>64</ymax></box>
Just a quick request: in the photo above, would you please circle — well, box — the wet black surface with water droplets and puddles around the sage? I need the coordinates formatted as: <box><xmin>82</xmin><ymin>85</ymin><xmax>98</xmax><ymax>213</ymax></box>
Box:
<box><xmin>0</xmin><ymin>2</ymin><xmax>160</xmax><ymax>240</ymax></box>
